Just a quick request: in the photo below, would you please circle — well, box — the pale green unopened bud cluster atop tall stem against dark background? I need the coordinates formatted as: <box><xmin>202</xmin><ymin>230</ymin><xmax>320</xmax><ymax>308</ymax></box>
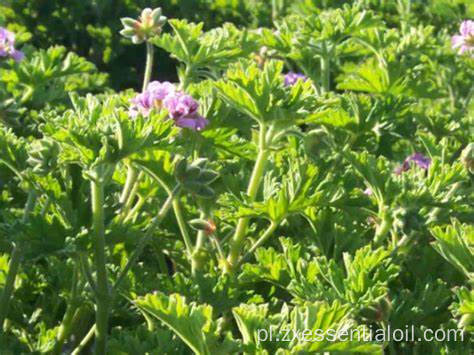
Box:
<box><xmin>120</xmin><ymin>7</ymin><xmax>167</xmax><ymax>44</ymax></box>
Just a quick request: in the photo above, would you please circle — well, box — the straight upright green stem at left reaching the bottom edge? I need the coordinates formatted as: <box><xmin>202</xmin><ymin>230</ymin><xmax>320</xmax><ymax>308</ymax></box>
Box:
<box><xmin>91</xmin><ymin>174</ymin><xmax>110</xmax><ymax>355</ymax></box>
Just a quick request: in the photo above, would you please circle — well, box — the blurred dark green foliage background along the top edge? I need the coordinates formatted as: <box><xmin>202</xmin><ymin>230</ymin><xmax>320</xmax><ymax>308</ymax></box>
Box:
<box><xmin>0</xmin><ymin>0</ymin><xmax>474</xmax><ymax>89</ymax></box>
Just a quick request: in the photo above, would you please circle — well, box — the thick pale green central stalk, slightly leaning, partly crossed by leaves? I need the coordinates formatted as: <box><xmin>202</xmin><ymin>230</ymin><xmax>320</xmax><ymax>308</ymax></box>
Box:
<box><xmin>226</xmin><ymin>125</ymin><xmax>270</xmax><ymax>272</ymax></box>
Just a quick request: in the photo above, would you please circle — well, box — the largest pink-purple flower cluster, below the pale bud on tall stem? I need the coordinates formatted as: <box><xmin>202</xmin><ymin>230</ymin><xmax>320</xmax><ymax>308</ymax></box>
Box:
<box><xmin>130</xmin><ymin>81</ymin><xmax>209</xmax><ymax>131</ymax></box>
